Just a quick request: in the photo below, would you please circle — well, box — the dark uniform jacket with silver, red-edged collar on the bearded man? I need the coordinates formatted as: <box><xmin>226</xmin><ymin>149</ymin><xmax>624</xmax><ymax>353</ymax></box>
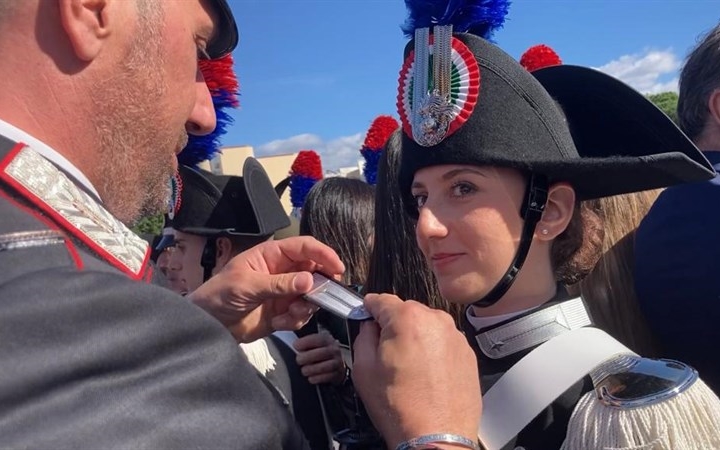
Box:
<box><xmin>0</xmin><ymin>138</ymin><xmax>307</xmax><ymax>450</ymax></box>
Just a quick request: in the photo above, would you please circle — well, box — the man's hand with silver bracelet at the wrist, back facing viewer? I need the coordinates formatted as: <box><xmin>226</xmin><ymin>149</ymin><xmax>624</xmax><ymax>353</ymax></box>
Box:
<box><xmin>353</xmin><ymin>294</ymin><xmax>482</xmax><ymax>448</ymax></box>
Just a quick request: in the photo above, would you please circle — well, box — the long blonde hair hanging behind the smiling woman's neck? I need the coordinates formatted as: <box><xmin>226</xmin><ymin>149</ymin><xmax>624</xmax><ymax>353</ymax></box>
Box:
<box><xmin>568</xmin><ymin>190</ymin><xmax>661</xmax><ymax>357</ymax></box>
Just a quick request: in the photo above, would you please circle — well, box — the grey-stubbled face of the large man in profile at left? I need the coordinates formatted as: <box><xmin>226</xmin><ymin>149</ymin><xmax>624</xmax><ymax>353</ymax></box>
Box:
<box><xmin>91</xmin><ymin>0</ymin><xmax>215</xmax><ymax>223</ymax></box>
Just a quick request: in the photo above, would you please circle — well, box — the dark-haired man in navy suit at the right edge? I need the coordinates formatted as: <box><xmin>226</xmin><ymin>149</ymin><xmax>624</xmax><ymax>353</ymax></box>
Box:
<box><xmin>635</xmin><ymin>25</ymin><xmax>720</xmax><ymax>393</ymax></box>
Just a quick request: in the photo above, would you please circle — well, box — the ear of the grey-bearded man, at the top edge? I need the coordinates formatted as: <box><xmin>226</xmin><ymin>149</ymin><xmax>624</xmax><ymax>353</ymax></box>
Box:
<box><xmin>58</xmin><ymin>0</ymin><xmax>111</xmax><ymax>62</ymax></box>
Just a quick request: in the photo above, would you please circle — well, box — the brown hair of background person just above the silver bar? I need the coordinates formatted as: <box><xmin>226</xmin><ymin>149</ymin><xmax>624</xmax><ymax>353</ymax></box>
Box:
<box><xmin>300</xmin><ymin>177</ymin><xmax>375</xmax><ymax>285</ymax></box>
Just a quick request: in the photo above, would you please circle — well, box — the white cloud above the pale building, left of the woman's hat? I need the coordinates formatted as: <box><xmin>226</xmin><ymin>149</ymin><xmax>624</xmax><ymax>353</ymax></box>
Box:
<box><xmin>255</xmin><ymin>133</ymin><xmax>365</xmax><ymax>171</ymax></box>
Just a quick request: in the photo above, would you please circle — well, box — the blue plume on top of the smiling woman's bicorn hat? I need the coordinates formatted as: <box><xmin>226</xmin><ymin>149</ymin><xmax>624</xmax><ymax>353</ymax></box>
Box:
<box><xmin>400</xmin><ymin>0</ymin><xmax>510</xmax><ymax>39</ymax></box>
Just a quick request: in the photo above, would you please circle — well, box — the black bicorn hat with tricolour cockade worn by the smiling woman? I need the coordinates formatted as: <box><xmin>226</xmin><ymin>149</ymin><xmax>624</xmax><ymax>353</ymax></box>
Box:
<box><xmin>398</xmin><ymin>31</ymin><xmax>714</xmax><ymax>212</ymax></box>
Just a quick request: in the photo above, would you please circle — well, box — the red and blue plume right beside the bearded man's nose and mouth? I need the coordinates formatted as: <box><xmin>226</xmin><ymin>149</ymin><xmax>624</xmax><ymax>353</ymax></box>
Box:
<box><xmin>178</xmin><ymin>55</ymin><xmax>240</xmax><ymax>167</ymax></box>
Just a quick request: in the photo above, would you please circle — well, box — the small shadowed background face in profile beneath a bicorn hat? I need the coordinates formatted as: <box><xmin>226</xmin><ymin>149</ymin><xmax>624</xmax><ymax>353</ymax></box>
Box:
<box><xmin>168</xmin><ymin>230</ymin><xmax>207</xmax><ymax>295</ymax></box>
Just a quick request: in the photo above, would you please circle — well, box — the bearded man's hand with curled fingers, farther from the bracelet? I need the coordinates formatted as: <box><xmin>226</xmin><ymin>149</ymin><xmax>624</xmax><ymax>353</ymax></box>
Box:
<box><xmin>189</xmin><ymin>236</ymin><xmax>345</xmax><ymax>342</ymax></box>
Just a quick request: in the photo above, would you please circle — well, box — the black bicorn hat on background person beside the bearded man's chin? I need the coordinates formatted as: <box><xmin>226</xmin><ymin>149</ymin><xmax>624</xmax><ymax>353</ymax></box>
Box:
<box><xmin>172</xmin><ymin>158</ymin><xmax>290</xmax><ymax>237</ymax></box>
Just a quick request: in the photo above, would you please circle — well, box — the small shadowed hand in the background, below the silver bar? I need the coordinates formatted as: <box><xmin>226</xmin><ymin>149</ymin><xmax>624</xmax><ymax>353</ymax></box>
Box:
<box><xmin>293</xmin><ymin>332</ymin><xmax>345</xmax><ymax>384</ymax></box>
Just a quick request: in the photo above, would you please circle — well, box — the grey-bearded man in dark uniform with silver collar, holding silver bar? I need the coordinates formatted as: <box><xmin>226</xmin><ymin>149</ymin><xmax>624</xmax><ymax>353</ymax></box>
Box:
<box><xmin>0</xmin><ymin>0</ymin><xmax>479</xmax><ymax>449</ymax></box>
